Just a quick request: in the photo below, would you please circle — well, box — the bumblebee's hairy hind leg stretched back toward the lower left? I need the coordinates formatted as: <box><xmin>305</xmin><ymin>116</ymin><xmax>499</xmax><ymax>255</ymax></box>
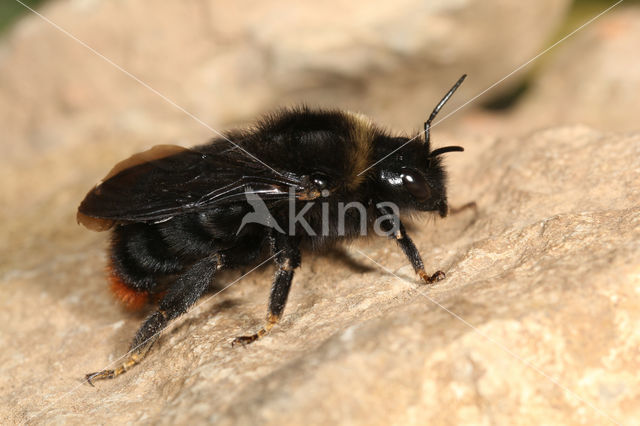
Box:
<box><xmin>85</xmin><ymin>255</ymin><xmax>220</xmax><ymax>386</ymax></box>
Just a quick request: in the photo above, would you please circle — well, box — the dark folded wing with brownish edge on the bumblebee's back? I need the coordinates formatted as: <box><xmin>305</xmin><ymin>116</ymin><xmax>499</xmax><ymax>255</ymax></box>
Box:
<box><xmin>77</xmin><ymin>145</ymin><xmax>302</xmax><ymax>231</ymax></box>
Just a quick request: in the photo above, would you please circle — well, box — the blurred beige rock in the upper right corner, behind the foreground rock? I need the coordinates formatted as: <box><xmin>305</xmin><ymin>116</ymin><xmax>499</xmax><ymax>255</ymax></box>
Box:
<box><xmin>508</xmin><ymin>7</ymin><xmax>640</xmax><ymax>135</ymax></box>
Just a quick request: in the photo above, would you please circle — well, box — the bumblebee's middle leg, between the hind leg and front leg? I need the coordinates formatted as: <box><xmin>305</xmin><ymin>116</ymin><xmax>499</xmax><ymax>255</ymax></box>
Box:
<box><xmin>231</xmin><ymin>233</ymin><xmax>300</xmax><ymax>346</ymax></box>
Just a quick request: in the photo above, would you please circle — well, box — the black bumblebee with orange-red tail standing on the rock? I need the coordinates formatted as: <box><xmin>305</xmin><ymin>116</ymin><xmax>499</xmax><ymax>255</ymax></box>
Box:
<box><xmin>78</xmin><ymin>76</ymin><xmax>466</xmax><ymax>383</ymax></box>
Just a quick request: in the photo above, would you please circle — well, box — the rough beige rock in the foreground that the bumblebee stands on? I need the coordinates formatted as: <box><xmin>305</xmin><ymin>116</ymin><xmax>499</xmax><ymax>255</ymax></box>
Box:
<box><xmin>0</xmin><ymin>126</ymin><xmax>640</xmax><ymax>424</ymax></box>
